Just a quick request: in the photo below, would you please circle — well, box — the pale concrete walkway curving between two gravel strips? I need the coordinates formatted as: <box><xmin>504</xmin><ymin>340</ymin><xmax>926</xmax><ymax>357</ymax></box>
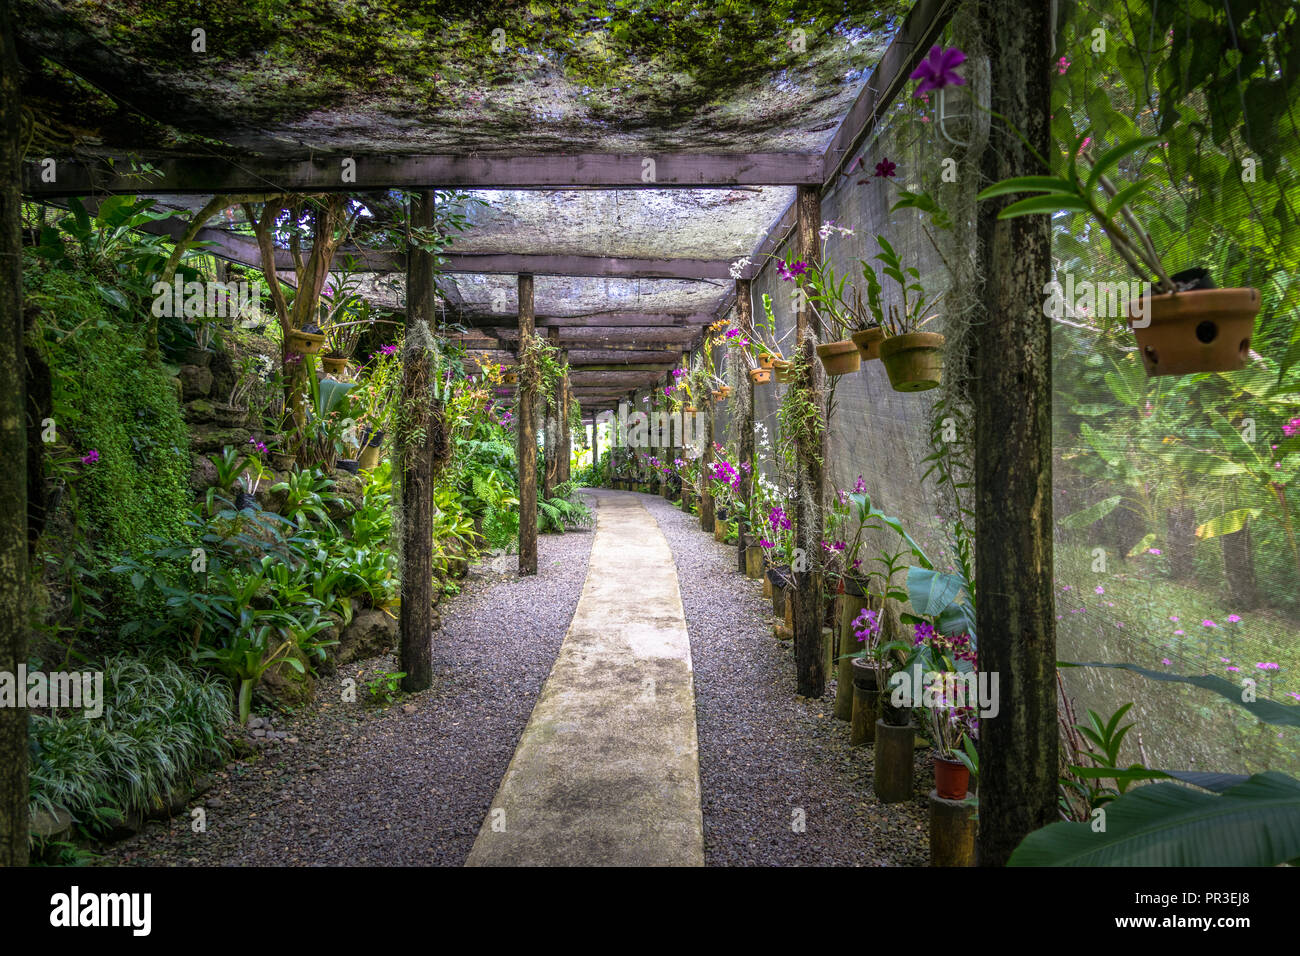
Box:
<box><xmin>465</xmin><ymin>490</ymin><xmax>705</xmax><ymax>866</ymax></box>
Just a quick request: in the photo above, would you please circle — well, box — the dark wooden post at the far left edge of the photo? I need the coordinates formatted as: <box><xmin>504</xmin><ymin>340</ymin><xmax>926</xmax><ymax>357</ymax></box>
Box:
<box><xmin>0</xmin><ymin>4</ymin><xmax>27</xmax><ymax>866</ymax></box>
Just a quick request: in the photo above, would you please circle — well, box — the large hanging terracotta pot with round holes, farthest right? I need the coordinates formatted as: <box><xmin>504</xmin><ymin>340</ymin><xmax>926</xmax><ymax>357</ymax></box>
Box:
<box><xmin>1130</xmin><ymin>289</ymin><xmax>1260</xmax><ymax>376</ymax></box>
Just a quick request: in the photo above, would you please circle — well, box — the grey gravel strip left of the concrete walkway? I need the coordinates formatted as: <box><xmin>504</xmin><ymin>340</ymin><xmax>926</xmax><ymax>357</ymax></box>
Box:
<box><xmin>104</xmin><ymin>522</ymin><xmax>593</xmax><ymax>866</ymax></box>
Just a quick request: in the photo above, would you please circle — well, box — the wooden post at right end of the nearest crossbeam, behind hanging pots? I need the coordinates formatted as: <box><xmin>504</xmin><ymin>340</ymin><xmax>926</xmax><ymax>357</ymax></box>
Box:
<box><xmin>781</xmin><ymin>186</ymin><xmax>826</xmax><ymax>697</ymax></box>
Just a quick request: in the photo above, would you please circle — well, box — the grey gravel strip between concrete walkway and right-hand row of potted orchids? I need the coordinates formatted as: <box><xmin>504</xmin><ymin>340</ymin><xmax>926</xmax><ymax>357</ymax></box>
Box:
<box><xmin>640</xmin><ymin>496</ymin><xmax>933</xmax><ymax>866</ymax></box>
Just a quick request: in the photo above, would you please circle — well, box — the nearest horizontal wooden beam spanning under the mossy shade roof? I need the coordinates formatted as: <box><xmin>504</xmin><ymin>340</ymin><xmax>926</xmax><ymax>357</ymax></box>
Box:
<box><xmin>22</xmin><ymin>152</ymin><xmax>823</xmax><ymax>198</ymax></box>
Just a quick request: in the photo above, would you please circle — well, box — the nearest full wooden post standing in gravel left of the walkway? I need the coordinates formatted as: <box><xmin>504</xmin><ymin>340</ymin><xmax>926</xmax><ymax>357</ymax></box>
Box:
<box><xmin>398</xmin><ymin>190</ymin><xmax>434</xmax><ymax>692</ymax></box>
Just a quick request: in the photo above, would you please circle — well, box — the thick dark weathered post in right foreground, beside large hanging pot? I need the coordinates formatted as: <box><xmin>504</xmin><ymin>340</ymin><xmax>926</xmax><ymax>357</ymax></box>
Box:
<box><xmin>970</xmin><ymin>0</ymin><xmax>1060</xmax><ymax>866</ymax></box>
